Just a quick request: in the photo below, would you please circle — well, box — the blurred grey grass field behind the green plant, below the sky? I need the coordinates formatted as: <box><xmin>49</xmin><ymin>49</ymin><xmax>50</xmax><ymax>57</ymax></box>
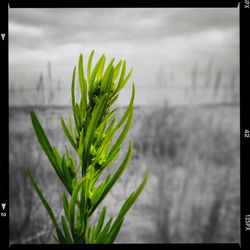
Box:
<box><xmin>9</xmin><ymin>105</ymin><xmax>240</xmax><ymax>243</ymax></box>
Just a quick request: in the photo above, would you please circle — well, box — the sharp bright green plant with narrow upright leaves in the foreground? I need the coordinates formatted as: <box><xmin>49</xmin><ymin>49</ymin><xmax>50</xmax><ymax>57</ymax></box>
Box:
<box><xmin>27</xmin><ymin>51</ymin><xmax>149</xmax><ymax>244</ymax></box>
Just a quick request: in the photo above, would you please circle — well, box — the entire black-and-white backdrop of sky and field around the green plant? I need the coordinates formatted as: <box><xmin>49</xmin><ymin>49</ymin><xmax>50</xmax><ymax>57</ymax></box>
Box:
<box><xmin>9</xmin><ymin>8</ymin><xmax>240</xmax><ymax>243</ymax></box>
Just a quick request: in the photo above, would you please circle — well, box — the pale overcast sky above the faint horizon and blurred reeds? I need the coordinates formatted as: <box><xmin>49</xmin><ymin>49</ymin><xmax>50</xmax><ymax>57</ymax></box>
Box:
<box><xmin>9</xmin><ymin>8</ymin><xmax>239</xmax><ymax>99</ymax></box>
